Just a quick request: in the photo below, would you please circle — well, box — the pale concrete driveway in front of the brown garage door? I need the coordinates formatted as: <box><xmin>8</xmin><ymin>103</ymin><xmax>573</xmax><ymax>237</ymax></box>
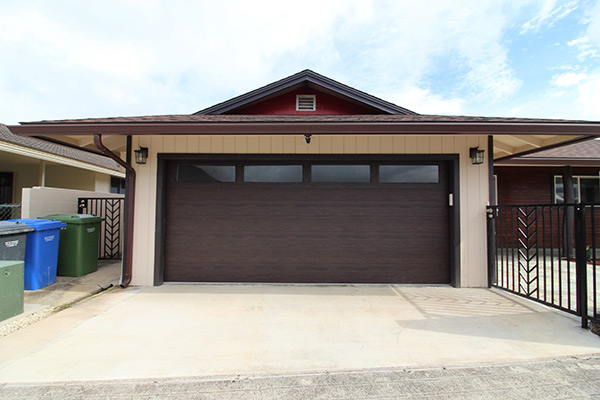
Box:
<box><xmin>0</xmin><ymin>284</ymin><xmax>600</xmax><ymax>382</ymax></box>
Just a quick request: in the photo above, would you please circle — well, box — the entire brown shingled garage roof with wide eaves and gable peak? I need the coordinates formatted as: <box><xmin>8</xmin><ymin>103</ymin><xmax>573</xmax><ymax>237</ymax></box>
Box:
<box><xmin>10</xmin><ymin>70</ymin><xmax>600</xmax><ymax>160</ymax></box>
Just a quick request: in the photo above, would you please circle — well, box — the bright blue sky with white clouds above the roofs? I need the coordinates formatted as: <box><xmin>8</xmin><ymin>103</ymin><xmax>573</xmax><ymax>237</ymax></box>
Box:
<box><xmin>0</xmin><ymin>0</ymin><xmax>600</xmax><ymax>124</ymax></box>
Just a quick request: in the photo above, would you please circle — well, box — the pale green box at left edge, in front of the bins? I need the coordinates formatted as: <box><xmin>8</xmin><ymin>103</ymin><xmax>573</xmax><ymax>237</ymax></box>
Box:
<box><xmin>0</xmin><ymin>260</ymin><xmax>25</xmax><ymax>321</ymax></box>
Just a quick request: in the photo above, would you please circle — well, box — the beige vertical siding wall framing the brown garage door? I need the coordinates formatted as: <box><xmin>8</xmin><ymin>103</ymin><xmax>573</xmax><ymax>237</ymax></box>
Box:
<box><xmin>132</xmin><ymin>135</ymin><xmax>488</xmax><ymax>287</ymax></box>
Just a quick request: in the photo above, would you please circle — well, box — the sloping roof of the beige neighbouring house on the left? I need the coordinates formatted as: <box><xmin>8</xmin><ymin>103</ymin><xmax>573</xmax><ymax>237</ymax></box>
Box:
<box><xmin>0</xmin><ymin>124</ymin><xmax>123</xmax><ymax>176</ymax></box>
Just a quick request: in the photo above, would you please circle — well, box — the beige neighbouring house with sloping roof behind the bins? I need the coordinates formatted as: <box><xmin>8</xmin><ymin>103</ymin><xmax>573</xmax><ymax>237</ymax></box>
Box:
<box><xmin>0</xmin><ymin>124</ymin><xmax>125</xmax><ymax>209</ymax></box>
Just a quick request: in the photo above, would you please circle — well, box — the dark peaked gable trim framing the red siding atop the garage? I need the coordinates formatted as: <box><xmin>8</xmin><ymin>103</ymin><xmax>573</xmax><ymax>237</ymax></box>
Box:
<box><xmin>194</xmin><ymin>69</ymin><xmax>417</xmax><ymax>115</ymax></box>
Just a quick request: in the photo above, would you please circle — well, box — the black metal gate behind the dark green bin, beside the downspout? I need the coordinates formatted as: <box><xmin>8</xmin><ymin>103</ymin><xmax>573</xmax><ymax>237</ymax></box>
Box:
<box><xmin>77</xmin><ymin>197</ymin><xmax>125</xmax><ymax>259</ymax></box>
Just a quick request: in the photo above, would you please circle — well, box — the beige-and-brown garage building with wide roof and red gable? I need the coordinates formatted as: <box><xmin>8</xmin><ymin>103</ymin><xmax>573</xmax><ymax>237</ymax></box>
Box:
<box><xmin>10</xmin><ymin>70</ymin><xmax>600</xmax><ymax>287</ymax></box>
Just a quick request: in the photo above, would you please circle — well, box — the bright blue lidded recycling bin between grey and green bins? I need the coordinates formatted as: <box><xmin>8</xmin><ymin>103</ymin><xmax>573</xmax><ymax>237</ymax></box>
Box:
<box><xmin>11</xmin><ymin>218</ymin><xmax>67</xmax><ymax>290</ymax></box>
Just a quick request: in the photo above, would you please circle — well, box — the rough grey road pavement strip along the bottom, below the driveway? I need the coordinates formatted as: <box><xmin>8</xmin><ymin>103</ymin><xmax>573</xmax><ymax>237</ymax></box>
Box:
<box><xmin>0</xmin><ymin>355</ymin><xmax>600</xmax><ymax>400</ymax></box>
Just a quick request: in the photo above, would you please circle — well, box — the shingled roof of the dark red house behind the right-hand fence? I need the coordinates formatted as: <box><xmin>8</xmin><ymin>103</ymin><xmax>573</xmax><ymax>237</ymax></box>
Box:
<box><xmin>495</xmin><ymin>138</ymin><xmax>600</xmax><ymax>166</ymax></box>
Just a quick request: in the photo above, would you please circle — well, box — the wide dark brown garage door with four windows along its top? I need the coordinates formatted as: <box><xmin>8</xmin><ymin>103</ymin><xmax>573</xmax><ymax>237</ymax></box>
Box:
<box><xmin>164</xmin><ymin>160</ymin><xmax>450</xmax><ymax>284</ymax></box>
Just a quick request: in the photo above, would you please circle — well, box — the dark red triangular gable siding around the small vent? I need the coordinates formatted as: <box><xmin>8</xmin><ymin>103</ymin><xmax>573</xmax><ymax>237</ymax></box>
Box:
<box><xmin>229</xmin><ymin>89</ymin><xmax>381</xmax><ymax>115</ymax></box>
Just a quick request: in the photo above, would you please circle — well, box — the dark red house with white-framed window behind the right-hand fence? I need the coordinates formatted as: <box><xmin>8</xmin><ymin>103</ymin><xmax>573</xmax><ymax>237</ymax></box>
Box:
<box><xmin>494</xmin><ymin>139</ymin><xmax>600</xmax><ymax>205</ymax></box>
